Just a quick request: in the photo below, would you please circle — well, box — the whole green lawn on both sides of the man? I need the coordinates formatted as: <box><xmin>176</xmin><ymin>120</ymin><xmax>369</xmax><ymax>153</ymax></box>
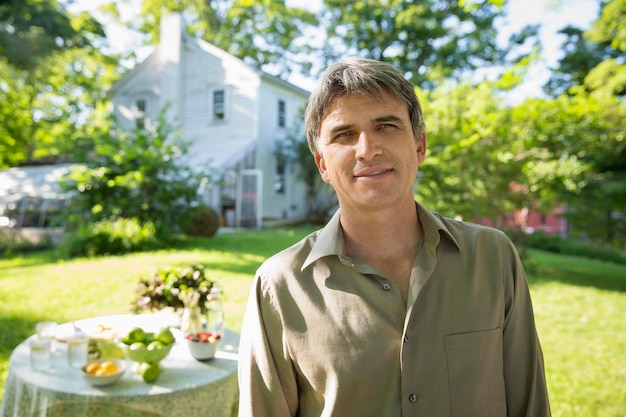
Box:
<box><xmin>0</xmin><ymin>227</ymin><xmax>626</xmax><ymax>417</ymax></box>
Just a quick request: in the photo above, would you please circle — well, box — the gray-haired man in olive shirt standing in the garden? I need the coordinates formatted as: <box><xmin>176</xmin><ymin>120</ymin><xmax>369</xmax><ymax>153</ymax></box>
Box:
<box><xmin>239</xmin><ymin>59</ymin><xmax>550</xmax><ymax>417</ymax></box>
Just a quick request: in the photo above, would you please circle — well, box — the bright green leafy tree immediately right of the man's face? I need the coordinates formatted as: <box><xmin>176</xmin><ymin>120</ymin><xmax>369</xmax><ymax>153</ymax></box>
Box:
<box><xmin>417</xmin><ymin>81</ymin><xmax>527</xmax><ymax>226</ymax></box>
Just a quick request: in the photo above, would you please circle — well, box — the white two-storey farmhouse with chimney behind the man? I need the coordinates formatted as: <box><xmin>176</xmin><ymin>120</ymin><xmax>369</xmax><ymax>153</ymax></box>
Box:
<box><xmin>110</xmin><ymin>14</ymin><xmax>316</xmax><ymax>227</ymax></box>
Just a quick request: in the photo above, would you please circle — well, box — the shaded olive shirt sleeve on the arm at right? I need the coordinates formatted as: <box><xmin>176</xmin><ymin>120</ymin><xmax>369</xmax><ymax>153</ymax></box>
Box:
<box><xmin>503</xmin><ymin>237</ymin><xmax>551</xmax><ymax>417</ymax></box>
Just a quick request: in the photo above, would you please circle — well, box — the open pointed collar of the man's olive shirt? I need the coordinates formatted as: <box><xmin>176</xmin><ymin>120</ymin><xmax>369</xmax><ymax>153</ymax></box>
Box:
<box><xmin>302</xmin><ymin>202</ymin><xmax>461</xmax><ymax>270</ymax></box>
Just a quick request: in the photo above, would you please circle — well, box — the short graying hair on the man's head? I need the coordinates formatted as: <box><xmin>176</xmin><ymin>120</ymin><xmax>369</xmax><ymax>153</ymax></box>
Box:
<box><xmin>304</xmin><ymin>58</ymin><xmax>426</xmax><ymax>154</ymax></box>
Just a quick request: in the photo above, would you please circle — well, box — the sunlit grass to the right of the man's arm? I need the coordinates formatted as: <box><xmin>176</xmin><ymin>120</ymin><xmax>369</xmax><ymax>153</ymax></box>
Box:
<box><xmin>529</xmin><ymin>252</ymin><xmax>626</xmax><ymax>417</ymax></box>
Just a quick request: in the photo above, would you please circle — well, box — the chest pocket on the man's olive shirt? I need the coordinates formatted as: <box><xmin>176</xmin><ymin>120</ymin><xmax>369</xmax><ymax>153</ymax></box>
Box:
<box><xmin>444</xmin><ymin>328</ymin><xmax>506</xmax><ymax>417</ymax></box>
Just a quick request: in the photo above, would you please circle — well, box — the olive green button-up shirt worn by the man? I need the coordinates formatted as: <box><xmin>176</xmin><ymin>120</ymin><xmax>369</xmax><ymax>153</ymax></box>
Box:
<box><xmin>239</xmin><ymin>204</ymin><xmax>550</xmax><ymax>417</ymax></box>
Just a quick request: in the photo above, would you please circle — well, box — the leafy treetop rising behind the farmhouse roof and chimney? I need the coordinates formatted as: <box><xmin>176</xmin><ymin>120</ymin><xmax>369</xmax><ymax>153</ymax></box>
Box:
<box><xmin>105</xmin><ymin>0</ymin><xmax>316</xmax><ymax>78</ymax></box>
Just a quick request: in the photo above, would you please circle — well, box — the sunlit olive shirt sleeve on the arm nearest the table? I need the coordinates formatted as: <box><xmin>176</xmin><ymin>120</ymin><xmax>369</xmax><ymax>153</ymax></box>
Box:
<box><xmin>238</xmin><ymin>275</ymin><xmax>298</xmax><ymax>417</ymax></box>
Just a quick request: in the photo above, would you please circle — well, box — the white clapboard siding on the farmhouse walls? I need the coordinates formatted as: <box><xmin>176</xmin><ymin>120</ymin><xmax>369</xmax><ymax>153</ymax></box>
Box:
<box><xmin>112</xmin><ymin>16</ymin><xmax>308</xmax><ymax>226</ymax></box>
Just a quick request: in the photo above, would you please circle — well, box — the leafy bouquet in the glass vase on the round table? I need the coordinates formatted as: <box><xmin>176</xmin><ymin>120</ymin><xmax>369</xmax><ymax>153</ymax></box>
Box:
<box><xmin>132</xmin><ymin>263</ymin><xmax>215</xmax><ymax>314</ymax></box>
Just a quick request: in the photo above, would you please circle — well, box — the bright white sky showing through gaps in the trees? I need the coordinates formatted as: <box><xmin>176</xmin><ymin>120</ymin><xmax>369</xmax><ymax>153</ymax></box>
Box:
<box><xmin>68</xmin><ymin>0</ymin><xmax>600</xmax><ymax>102</ymax></box>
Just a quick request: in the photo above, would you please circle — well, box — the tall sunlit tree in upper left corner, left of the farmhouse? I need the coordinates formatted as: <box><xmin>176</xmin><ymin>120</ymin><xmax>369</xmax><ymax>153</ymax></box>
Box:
<box><xmin>0</xmin><ymin>0</ymin><xmax>119</xmax><ymax>167</ymax></box>
